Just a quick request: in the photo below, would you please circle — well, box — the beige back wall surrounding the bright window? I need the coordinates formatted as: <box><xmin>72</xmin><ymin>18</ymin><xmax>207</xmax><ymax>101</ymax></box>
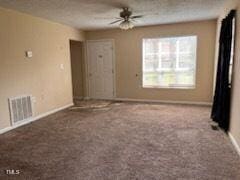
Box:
<box><xmin>86</xmin><ymin>20</ymin><xmax>217</xmax><ymax>102</ymax></box>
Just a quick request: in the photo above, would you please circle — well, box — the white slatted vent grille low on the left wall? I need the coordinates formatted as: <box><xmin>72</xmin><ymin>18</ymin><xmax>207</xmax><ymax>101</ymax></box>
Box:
<box><xmin>9</xmin><ymin>96</ymin><xmax>33</xmax><ymax>125</ymax></box>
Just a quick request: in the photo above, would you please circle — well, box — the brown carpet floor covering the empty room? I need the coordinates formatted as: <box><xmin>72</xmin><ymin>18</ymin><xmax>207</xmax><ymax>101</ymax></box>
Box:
<box><xmin>0</xmin><ymin>102</ymin><xmax>240</xmax><ymax>180</ymax></box>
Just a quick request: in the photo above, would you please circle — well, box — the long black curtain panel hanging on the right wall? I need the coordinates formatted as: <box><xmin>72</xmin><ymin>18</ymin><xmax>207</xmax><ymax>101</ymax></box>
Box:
<box><xmin>211</xmin><ymin>10</ymin><xmax>235</xmax><ymax>131</ymax></box>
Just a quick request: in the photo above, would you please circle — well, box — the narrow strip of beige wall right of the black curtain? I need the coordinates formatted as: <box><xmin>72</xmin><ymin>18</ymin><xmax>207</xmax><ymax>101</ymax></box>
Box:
<box><xmin>230</xmin><ymin>2</ymin><xmax>240</xmax><ymax>150</ymax></box>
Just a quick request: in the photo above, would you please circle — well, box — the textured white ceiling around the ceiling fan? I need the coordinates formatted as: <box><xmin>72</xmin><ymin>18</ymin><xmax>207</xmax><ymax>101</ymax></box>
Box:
<box><xmin>0</xmin><ymin>0</ymin><xmax>229</xmax><ymax>30</ymax></box>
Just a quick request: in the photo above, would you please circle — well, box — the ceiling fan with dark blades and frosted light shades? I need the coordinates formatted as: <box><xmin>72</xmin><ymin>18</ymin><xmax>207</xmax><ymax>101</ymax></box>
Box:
<box><xmin>110</xmin><ymin>7</ymin><xmax>143</xmax><ymax>30</ymax></box>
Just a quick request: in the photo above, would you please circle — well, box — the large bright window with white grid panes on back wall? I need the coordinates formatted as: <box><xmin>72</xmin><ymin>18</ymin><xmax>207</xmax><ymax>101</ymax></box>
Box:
<box><xmin>143</xmin><ymin>36</ymin><xmax>197</xmax><ymax>89</ymax></box>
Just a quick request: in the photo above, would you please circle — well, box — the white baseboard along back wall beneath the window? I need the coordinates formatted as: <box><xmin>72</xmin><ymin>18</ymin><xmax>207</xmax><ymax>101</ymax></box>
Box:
<box><xmin>113</xmin><ymin>98</ymin><xmax>212</xmax><ymax>106</ymax></box>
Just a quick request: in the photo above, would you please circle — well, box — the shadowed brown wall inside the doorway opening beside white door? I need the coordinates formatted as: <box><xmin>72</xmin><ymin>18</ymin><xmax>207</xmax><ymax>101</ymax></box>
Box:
<box><xmin>70</xmin><ymin>41</ymin><xmax>84</xmax><ymax>99</ymax></box>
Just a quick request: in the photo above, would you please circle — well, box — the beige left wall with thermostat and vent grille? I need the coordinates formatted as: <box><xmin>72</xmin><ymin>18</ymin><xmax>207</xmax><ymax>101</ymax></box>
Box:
<box><xmin>0</xmin><ymin>8</ymin><xmax>84</xmax><ymax>129</ymax></box>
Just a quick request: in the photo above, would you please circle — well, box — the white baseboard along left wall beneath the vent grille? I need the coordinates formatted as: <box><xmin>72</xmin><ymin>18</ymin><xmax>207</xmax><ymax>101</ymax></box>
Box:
<box><xmin>0</xmin><ymin>103</ymin><xmax>73</xmax><ymax>134</ymax></box>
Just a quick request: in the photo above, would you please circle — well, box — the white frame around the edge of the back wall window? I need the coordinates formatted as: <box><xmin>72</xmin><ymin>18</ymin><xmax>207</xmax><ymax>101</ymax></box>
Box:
<box><xmin>141</xmin><ymin>34</ymin><xmax>198</xmax><ymax>90</ymax></box>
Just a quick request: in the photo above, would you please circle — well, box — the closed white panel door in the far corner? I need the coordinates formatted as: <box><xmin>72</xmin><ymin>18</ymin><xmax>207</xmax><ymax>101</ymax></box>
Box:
<box><xmin>87</xmin><ymin>40</ymin><xmax>114</xmax><ymax>99</ymax></box>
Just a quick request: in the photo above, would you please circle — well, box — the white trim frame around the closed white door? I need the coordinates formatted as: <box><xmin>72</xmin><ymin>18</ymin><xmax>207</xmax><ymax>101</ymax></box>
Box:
<box><xmin>86</xmin><ymin>39</ymin><xmax>116</xmax><ymax>99</ymax></box>
